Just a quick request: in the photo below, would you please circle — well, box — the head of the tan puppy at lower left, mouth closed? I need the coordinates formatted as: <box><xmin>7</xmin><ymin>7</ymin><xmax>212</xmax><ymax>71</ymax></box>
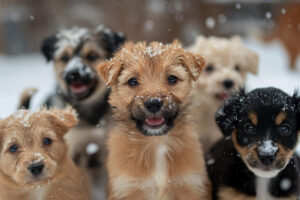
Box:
<box><xmin>0</xmin><ymin>108</ymin><xmax>77</xmax><ymax>188</ymax></box>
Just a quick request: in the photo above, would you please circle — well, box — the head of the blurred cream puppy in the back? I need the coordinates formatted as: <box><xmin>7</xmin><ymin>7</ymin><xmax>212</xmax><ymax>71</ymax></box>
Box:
<box><xmin>190</xmin><ymin>36</ymin><xmax>258</xmax><ymax>106</ymax></box>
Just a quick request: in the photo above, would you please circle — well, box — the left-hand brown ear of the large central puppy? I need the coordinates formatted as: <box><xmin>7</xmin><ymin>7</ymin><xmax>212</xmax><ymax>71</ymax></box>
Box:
<box><xmin>97</xmin><ymin>58</ymin><xmax>122</xmax><ymax>87</ymax></box>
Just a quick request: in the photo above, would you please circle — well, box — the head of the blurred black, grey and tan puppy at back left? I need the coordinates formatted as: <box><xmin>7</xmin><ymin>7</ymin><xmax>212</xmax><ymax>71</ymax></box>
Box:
<box><xmin>42</xmin><ymin>26</ymin><xmax>125</xmax><ymax>101</ymax></box>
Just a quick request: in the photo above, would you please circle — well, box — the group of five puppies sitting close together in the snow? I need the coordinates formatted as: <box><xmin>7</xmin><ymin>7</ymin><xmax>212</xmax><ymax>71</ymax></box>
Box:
<box><xmin>0</xmin><ymin>26</ymin><xmax>300</xmax><ymax>200</ymax></box>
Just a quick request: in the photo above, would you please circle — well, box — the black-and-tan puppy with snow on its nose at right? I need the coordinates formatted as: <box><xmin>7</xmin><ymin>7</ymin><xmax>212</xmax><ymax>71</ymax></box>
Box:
<box><xmin>207</xmin><ymin>88</ymin><xmax>300</xmax><ymax>200</ymax></box>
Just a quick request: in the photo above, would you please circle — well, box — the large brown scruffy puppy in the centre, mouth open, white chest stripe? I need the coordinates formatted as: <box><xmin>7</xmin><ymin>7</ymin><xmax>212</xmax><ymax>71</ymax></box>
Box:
<box><xmin>98</xmin><ymin>41</ymin><xmax>210</xmax><ymax>200</ymax></box>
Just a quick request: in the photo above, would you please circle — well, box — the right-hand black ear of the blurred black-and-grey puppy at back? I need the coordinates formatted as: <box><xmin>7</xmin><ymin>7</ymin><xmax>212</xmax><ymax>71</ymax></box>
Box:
<box><xmin>95</xmin><ymin>25</ymin><xmax>126</xmax><ymax>58</ymax></box>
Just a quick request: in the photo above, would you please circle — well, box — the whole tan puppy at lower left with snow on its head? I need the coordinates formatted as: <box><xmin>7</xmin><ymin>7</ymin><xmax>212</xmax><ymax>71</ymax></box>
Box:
<box><xmin>0</xmin><ymin>108</ymin><xmax>89</xmax><ymax>200</ymax></box>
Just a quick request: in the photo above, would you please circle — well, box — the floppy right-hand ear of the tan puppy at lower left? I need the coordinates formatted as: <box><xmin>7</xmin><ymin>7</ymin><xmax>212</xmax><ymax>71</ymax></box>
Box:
<box><xmin>46</xmin><ymin>106</ymin><xmax>78</xmax><ymax>134</ymax></box>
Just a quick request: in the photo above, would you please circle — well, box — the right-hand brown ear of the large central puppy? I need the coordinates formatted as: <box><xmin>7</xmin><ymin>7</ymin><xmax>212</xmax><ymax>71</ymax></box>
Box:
<box><xmin>183</xmin><ymin>51</ymin><xmax>205</xmax><ymax>81</ymax></box>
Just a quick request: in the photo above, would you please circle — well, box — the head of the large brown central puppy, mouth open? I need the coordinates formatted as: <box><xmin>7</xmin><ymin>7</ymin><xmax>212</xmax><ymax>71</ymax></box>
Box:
<box><xmin>98</xmin><ymin>41</ymin><xmax>204</xmax><ymax>135</ymax></box>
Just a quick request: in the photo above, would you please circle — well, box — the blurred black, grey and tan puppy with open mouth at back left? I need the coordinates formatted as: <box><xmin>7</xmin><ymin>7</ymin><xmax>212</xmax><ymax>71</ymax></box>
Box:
<box><xmin>21</xmin><ymin>25</ymin><xmax>125</xmax><ymax>199</ymax></box>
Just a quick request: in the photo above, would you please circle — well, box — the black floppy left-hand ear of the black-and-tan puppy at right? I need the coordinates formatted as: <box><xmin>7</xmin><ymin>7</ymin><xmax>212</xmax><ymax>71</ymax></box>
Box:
<box><xmin>215</xmin><ymin>90</ymin><xmax>245</xmax><ymax>137</ymax></box>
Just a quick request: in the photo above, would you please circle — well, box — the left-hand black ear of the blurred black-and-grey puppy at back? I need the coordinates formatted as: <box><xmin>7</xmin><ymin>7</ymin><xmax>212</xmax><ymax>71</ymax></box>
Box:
<box><xmin>41</xmin><ymin>35</ymin><xmax>58</xmax><ymax>62</ymax></box>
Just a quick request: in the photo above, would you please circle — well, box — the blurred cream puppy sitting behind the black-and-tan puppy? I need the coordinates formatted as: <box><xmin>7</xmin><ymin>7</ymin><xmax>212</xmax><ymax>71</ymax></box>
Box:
<box><xmin>188</xmin><ymin>36</ymin><xmax>258</xmax><ymax>152</ymax></box>
